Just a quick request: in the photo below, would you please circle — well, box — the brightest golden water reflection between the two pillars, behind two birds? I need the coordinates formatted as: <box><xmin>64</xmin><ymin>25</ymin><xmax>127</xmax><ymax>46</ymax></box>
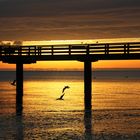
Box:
<box><xmin>24</xmin><ymin>81</ymin><xmax>84</xmax><ymax>111</ymax></box>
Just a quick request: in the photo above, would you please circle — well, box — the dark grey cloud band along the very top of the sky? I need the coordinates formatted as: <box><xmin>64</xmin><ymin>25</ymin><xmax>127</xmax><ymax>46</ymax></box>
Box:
<box><xmin>0</xmin><ymin>0</ymin><xmax>140</xmax><ymax>17</ymax></box>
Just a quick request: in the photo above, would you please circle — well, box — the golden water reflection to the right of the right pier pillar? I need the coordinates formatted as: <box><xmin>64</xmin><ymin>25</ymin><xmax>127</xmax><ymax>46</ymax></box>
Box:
<box><xmin>92</xmin><ymin>81</ymin><xmax>140</xmax><ymax>109</ymax></box>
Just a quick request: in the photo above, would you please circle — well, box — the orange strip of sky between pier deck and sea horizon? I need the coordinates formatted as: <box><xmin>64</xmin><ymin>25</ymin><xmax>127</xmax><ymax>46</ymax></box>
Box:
<box><xmin>0</xmin><ymin>60</ymin><xmax>140</xmax><ymax>70</ymax></box>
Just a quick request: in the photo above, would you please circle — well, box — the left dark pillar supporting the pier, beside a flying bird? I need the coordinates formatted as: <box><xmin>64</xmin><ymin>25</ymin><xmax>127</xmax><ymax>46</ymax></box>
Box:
<box><xmin>16</xmin><ymin>63</ymin><xmax>23</xmax><ymax>115</ymax></box>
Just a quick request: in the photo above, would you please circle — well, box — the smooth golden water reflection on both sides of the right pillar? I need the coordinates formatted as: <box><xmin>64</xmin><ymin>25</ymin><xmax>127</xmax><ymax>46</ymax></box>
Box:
<box><xmin>24</xmin><ymin>81</ymin><xmax>140</xmax><ymax>111</ymax></box>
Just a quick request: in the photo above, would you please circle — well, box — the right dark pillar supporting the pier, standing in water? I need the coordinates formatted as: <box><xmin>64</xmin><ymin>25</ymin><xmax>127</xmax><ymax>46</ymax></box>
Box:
<box><xmin>84</xmin><ymin>61</ymin><xmax>92</xmax><ymax>110</ymax></box>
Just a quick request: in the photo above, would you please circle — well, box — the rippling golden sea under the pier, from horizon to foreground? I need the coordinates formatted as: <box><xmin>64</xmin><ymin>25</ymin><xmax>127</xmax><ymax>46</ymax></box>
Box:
<box><xmin>0</xmin><ymin>69</ymin><xmax>140</xmax><ymax>140</ymax></box>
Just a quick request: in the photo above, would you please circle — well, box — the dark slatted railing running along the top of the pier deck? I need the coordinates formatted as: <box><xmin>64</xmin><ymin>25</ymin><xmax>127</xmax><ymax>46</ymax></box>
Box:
<box><xmin>0</xmin><ymin>42</ymin><xmax>140</xmax><ymax>56</ymax></box>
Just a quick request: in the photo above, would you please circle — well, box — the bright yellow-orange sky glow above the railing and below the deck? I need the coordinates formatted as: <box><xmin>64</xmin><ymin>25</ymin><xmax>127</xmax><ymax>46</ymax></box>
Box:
<box><xmin>0</xmin><ymin>38</ymin><xmax>140</xmax><ymax>70</ymax></box>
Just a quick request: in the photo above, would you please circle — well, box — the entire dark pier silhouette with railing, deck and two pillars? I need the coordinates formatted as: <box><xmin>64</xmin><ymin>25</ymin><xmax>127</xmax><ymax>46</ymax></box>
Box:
<box><xmin>0</xmin><ymin>42</ymin><xmax>140</xmax><ymax>113</ymax></box>
